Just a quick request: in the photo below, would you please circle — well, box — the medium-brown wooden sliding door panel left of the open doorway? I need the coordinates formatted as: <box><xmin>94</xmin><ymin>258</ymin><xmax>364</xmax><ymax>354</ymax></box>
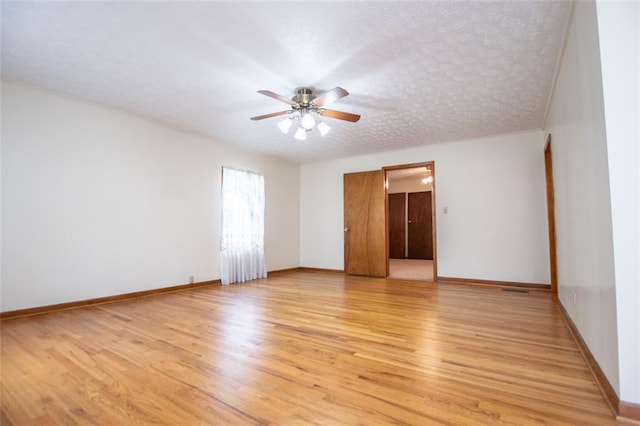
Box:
<box><xmin>344</xmin><ymin>170</ymin><xmax>388</xmax><ymax>277</ymax></box>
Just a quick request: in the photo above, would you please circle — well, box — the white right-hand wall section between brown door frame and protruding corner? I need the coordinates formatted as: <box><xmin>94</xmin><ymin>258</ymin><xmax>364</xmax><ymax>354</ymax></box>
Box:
<box><xmin>546</xmin><ymin>2</ymin><xmax>619</xmax><ymax>400</ymax></box>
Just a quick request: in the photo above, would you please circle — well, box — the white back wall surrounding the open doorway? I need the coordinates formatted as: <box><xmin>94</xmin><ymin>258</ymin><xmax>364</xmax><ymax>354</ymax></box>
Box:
<box><xmin>300</xmin><ymin>131</ymin><xmax>549</xmax><ymax>284</ymax></box>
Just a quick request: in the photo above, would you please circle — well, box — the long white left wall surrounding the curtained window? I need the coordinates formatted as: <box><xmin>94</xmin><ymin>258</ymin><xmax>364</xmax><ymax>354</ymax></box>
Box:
<box><xmin>1</xmin><ymin>81</ymin><xmax>299</xmax><ymax>312</ymax></box>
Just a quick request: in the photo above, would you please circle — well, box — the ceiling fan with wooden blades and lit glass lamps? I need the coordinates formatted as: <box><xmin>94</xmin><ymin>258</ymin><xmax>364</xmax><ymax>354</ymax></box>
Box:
<box><xmin>251</xmin><ymin>87</ymin><xmax>360</xmax><ymax>140</ymax></box>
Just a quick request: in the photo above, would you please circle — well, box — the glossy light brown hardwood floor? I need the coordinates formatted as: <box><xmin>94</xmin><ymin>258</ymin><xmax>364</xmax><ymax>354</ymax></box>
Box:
<box><xmin>1</xmin><ymin>272</ymin><xmax>616</xmax><ymax>426</ymax></box>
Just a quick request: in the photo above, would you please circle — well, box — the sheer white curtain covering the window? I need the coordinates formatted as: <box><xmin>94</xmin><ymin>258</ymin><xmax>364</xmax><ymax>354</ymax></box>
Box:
<box><xmin>220</xmin><ymin>167</ymin><xmax>267</xmax><ymax>285</ymax></box>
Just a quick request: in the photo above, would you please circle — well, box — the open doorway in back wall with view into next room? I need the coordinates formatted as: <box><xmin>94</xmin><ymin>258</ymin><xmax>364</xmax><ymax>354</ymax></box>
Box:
<box><xmin>384</xmin><ymin>162</ymin><xmax>437</xmax><ymax>281</ymax></box>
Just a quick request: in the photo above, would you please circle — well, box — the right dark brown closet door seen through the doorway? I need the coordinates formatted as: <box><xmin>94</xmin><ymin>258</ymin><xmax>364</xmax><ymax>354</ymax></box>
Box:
<box><xmin>407</xmin><ymin>191</ymin><xmax>433</xmax><ymax>259</ymax></box>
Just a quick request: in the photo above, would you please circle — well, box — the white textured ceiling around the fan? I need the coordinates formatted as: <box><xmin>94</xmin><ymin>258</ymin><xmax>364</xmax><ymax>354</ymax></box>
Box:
<box><xmin>1</xmin><ymin>1</ymin><xmax>572</xmax><ymax>163</ymax></box>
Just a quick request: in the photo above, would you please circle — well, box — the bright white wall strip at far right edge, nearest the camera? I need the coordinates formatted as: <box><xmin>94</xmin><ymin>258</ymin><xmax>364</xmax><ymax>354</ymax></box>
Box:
<box><xmin>596</xmin><ymin>1</ymin><xmax>640</xmax><ymax>404</ymax></box>
